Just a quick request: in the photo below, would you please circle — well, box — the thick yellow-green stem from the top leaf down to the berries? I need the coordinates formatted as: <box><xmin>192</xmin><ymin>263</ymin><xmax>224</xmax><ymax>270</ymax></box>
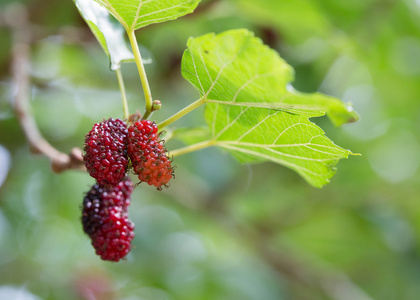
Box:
<box><xmin>127</xmin><ymin>29</ymin><xmax>153</xmax><ymax>119</ymax></box>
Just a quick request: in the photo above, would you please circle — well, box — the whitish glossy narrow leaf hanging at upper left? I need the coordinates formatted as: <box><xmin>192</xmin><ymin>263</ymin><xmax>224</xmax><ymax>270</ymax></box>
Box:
<box><xmin>74</xmin><ymin>0</ymin><xmax>134</xmax><ymax>71</ymax></box>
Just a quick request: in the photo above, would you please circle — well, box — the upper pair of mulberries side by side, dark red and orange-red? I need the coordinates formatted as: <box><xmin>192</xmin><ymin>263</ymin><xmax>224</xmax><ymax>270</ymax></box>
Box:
<box><xmin>83</xmin><ymin>119</ymin><xmax>174</xmax><ymax>190</ymax></box>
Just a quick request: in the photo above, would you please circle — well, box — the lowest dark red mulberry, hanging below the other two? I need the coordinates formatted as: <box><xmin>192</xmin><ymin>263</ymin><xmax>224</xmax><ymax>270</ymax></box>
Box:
<box><xmin>82</xmin><ymin>177</ymin><xmax>134</xmax><ymax>261</ymax></box>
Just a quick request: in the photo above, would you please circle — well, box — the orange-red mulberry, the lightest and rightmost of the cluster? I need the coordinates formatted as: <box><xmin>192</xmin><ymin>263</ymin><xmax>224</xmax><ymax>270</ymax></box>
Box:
<box><xmin>127</xmin><ymin>120</ymin><xmax>174</xmax><ymax>190</ymax></box>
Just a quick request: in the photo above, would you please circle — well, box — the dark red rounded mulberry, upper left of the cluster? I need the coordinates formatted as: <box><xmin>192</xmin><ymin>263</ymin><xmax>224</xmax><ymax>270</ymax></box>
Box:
<box><xmin>83</xmin><ymin>119</ymin><xmax>128</xmax><ymax>187</ymax></box>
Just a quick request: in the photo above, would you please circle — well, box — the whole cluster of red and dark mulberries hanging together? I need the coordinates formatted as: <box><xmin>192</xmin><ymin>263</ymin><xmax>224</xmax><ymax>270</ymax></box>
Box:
<box><xmin>82</xmin><ymin>119</ymin><xmax>174</xmax><ymax>261</ymax></box>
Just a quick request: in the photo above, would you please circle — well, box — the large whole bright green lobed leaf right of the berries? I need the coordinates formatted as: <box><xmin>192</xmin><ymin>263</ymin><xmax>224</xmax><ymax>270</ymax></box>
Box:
<box><xmin>182</xmin><ymin>30</ymin><xmax>357</xmax><ymax>187</ymax></box>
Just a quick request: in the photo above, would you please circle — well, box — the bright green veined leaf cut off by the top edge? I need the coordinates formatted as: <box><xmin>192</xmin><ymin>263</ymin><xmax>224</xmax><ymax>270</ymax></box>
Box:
<box><xmin>96</xmin><ymin>0</ymin><xmax>200</xmax><ymax>30</ymax></box>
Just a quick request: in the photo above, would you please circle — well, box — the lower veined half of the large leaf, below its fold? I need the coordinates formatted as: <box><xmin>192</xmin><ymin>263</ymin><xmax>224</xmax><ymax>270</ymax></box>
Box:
<box><xmin>206</xmin><ymin>104</ymin><xmax>351</xmax><ymax>187</ymax></box>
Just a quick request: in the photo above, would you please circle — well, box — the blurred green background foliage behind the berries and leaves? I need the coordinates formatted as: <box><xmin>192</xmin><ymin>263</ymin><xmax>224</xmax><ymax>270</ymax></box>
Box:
<box><xmin>0</xmin><ymin>0</ymin><xmax>420</xmax><ymax>300</ymax></box>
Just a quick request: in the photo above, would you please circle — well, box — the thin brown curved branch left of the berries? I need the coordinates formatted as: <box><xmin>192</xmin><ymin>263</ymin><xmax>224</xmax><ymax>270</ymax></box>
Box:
<box><xmin>6</xmin><ymin>3</ymin><xmax>84</xmax><ymax>173</ymax></box>
